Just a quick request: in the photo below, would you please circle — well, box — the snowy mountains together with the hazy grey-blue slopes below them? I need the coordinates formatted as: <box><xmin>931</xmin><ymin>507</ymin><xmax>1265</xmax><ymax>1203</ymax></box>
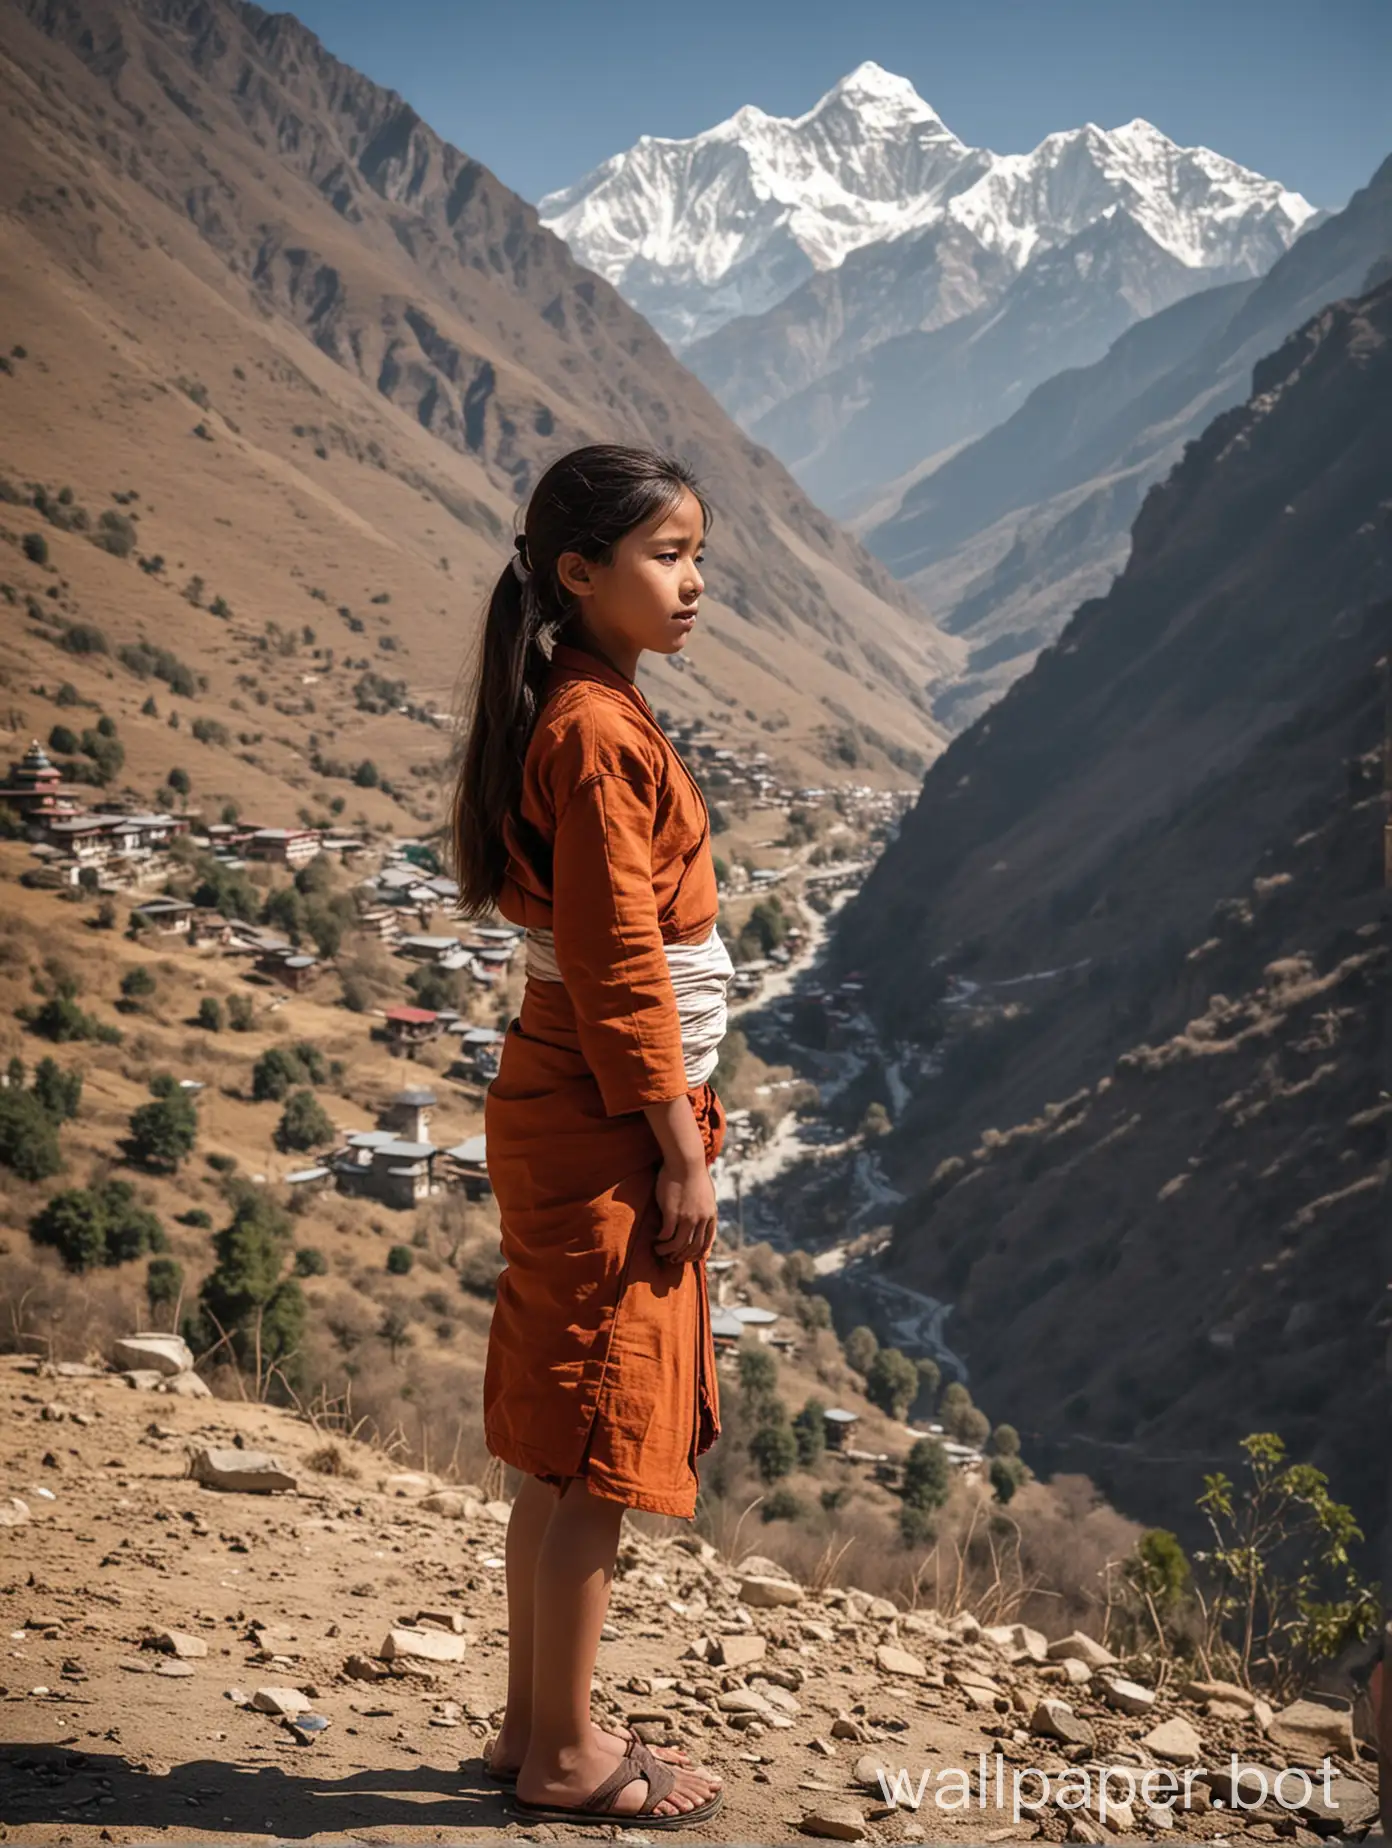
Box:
<box><xmin>540</xmin><ymin>63</ymin><xmax>1314</xmax><ymax>512</ymax></box>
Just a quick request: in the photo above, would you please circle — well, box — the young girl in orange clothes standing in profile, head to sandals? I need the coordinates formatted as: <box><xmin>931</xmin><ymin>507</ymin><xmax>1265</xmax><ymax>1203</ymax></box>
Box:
<box><xmin>455</xmin><ymin>445</ymin><xmax>732</xmax><ymax>1828</ymax></box>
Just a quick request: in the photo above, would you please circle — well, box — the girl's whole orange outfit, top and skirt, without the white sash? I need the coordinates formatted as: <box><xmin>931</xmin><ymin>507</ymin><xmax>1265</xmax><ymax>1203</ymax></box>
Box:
<box><xmin>484</xmin><ymin>643</ymin><xmax>725</xmax><ymax>1519</ymax></box>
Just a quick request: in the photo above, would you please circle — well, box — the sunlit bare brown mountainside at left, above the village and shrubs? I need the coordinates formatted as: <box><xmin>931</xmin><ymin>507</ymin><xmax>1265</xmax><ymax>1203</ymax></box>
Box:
<box><xmin>0</xmin><ymin>0</ymin><xmax>959</xmax><ymax>821</ymax></box>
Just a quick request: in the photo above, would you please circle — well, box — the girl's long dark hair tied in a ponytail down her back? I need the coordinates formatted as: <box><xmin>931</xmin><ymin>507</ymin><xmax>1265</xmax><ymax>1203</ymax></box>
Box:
<box><xmin>453</xmin><ymin>444</ymin><xmax>712</xmax><ymax>917</ymax></box>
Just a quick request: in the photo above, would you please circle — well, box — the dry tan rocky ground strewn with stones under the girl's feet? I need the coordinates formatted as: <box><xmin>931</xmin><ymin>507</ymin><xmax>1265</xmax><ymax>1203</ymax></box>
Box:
<box><xmin>0</xmin><ymin>1358</ymin><xmax>1375</xmax><ymax>1848</ymax></box>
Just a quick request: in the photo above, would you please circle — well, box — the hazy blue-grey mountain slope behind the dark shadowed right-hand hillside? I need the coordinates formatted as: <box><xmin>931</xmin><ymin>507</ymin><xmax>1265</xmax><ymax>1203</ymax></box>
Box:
<box><xmin>856</xmin><ymin>161</ymin><xmax>1392</xmax><ymax>730</ymax></box>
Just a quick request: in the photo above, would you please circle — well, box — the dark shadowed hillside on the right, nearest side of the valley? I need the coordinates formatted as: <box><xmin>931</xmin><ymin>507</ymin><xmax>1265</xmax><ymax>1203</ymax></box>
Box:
<box><xmin>834</xmin><ymin>269</ymin><xmax>1392</xmax><ymax>1559</ymax></box>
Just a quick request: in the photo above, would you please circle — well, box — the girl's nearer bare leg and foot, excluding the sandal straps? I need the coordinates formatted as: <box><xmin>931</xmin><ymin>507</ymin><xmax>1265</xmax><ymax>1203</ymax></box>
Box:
<box><xmin>518</xmin><ymin>1478</ymin><xmax>721</xmax><ymax>1815</ymax></box>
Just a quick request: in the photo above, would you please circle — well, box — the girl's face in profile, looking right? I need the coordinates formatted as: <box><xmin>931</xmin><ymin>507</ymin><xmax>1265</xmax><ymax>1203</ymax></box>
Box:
<box><xmin>556</xmin><ymin>488</ymin><xmax>706</xmax><ymax>680</ymax></box>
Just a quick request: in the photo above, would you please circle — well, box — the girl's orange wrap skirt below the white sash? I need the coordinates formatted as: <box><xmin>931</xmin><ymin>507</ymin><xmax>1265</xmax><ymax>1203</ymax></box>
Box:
<box><xmin>484</xmin><ymin>981</ymin><xmax>725</xmax><ymax>1519</ymax></box>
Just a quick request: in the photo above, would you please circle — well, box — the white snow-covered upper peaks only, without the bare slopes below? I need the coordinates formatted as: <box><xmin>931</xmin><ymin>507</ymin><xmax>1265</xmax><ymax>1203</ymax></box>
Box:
<box><xmin>540</xmin><ymin>59</ymin><xmax>1313</xmax><ymax>347</ymax></box>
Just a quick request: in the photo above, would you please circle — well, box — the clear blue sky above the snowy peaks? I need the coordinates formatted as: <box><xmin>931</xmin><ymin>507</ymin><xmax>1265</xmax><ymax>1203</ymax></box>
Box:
<box><xmin>279</xmin><ymin>0</ymin><xmax>1392</xmax><ymax>207</ymax></box>
